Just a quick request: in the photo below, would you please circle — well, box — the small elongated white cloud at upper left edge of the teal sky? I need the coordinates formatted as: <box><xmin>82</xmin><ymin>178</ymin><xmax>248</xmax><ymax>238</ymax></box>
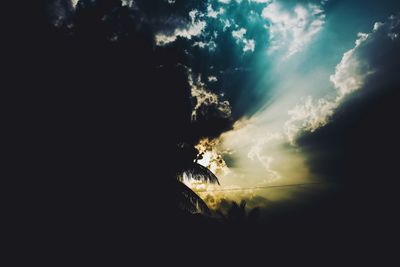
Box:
<box><xmin>155</xmin><ymin>10</ymin><xmax>207</xmax><ymax>46</ymax></box>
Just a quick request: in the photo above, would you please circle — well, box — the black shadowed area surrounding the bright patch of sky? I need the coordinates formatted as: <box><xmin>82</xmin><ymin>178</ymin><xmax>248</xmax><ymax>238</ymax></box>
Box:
<box><xmin>5</xmin><ymin>0</ymin><xmax>400</xmax><ymax>266</ymax></box>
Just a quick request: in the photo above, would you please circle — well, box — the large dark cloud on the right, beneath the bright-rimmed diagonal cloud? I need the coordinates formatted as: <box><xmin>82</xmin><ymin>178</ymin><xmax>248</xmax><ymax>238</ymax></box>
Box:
<box><xmin>299</xmin><ymin>13</ymin><xmax>400</xmax><ymax>232</ymax></box>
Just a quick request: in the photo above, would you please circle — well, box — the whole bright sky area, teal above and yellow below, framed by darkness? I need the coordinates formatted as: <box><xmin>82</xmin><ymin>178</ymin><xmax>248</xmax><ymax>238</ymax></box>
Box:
<box><xmin>151</xmin><ymin>1</ymin><xmax>399</xmax><ymax>214</ymax></box>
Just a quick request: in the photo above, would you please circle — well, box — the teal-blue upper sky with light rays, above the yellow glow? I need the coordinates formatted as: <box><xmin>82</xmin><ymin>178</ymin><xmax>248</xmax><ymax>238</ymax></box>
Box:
<box><xmin>152</xmin><ymin>0</ymin><xmax>399</xmax><ymax>119</ymax></box>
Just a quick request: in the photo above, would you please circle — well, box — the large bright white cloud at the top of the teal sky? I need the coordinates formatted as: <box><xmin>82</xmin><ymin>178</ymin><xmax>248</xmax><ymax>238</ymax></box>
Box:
<box><xmin>262</xmin><ymin>2</ymin><xmax>325</xmax><ymax>58</ymax></box>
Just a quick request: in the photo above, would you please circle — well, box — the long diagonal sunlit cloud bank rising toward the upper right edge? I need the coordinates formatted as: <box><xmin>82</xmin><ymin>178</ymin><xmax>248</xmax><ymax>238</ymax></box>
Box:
<box><xmin>285</xmin><ymin>16</ymin><xmax>399</xmax><ymax>143</ymax></box>
